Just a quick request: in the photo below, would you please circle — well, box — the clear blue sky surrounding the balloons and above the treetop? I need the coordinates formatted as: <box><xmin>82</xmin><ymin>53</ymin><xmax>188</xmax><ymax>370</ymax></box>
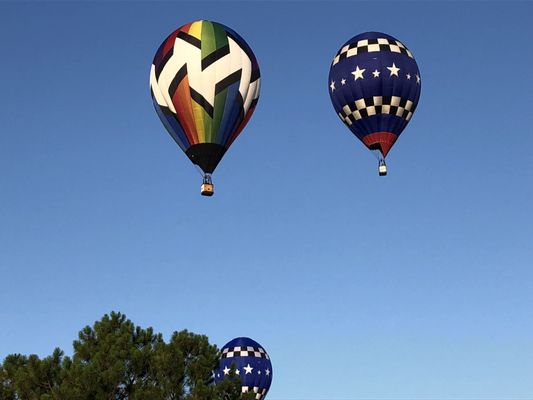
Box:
<box><xmin>0</xmin><ymin>1</ymin><xmax>533</xmax><ymax>400</ymax></box>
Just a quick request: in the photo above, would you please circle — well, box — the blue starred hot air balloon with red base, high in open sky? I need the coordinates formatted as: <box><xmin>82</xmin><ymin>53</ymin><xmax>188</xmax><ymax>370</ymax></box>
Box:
<box><xmin>328</xmin><ymin>32</ymin><xmax>420</xmax><ymax>176</ymax></box>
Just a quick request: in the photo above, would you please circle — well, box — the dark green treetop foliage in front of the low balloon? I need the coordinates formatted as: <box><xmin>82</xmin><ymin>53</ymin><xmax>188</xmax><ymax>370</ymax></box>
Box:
<box><xmin>0</xmin><ymin>312</ymin><xmax>254</xmax><ymax>400</ymax></box>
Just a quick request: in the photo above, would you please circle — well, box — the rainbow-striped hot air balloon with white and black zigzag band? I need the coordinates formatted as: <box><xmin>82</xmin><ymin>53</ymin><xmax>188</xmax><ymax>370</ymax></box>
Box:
<box><xmin>150</xmin><ymin>20</ymin><xmax>260</xmax><ymax>196</ymax></box>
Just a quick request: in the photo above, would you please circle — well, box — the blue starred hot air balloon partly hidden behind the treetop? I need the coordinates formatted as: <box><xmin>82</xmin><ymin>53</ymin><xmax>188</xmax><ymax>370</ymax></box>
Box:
<box><xmin>215</xmin><ymin>337</ymin><xmax>272</xmax><ymax>400</ymax></box>
